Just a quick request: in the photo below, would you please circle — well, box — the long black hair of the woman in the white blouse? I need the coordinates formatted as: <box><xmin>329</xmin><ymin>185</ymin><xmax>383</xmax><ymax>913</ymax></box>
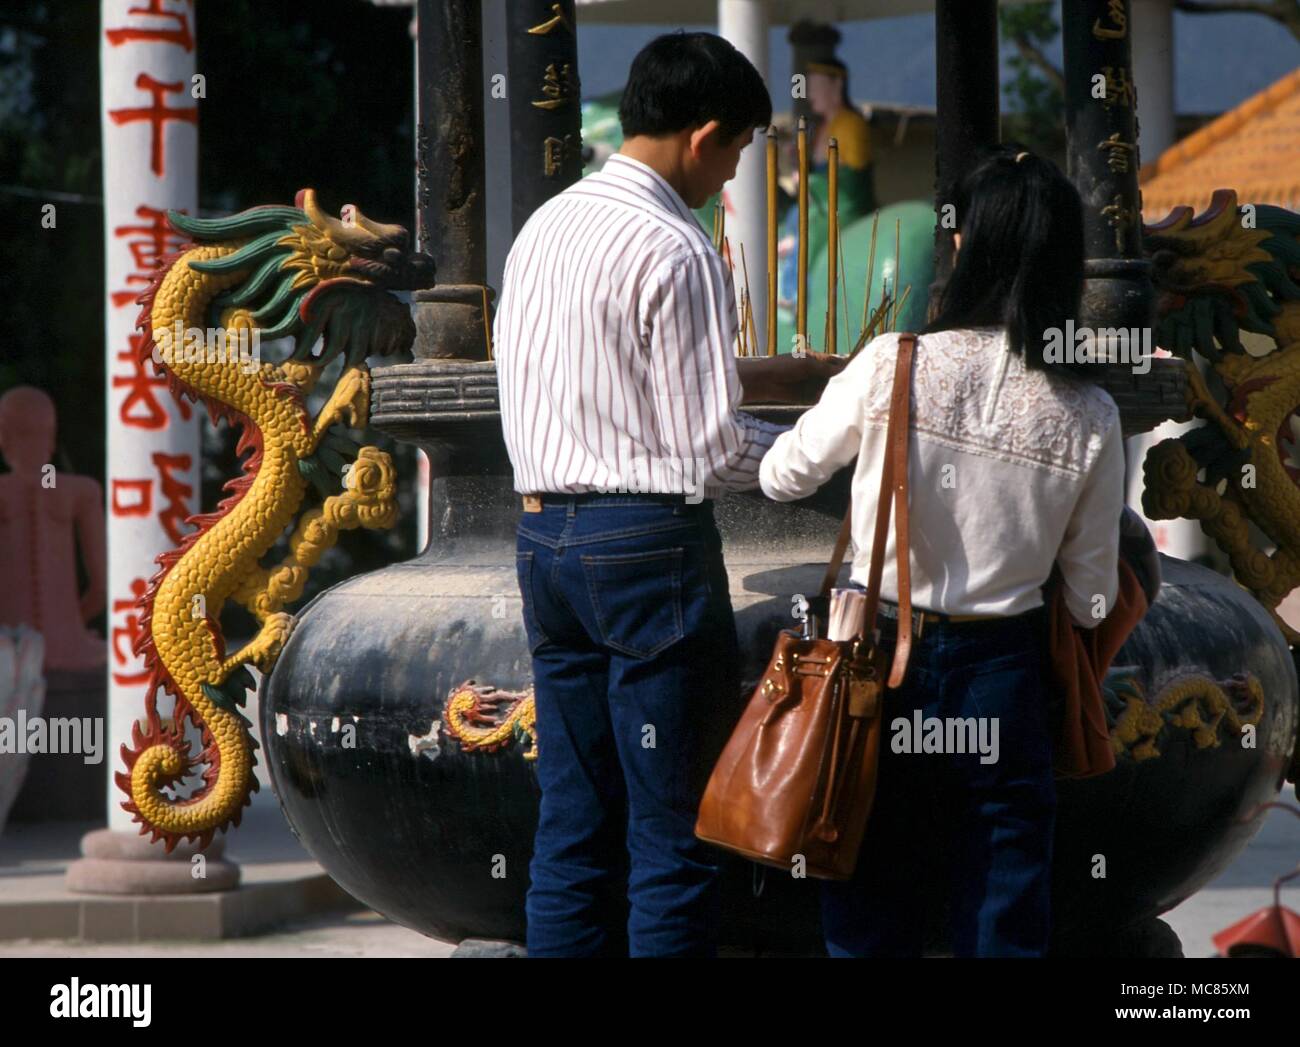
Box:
<box><xmin>920</xmin><ymin>143</ymin><xmax>1097</xmax><ymax>380</ymax></box>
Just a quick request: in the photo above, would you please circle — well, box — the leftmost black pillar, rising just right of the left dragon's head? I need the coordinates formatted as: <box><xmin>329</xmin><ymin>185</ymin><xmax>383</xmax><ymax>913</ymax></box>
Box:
<box><xmin>412</xmin><ymin>0</ymin><xmax>490</xmax><ymax>360</ymax></box>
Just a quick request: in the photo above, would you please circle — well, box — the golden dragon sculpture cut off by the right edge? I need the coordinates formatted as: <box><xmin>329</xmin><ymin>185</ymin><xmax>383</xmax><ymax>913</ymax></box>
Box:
<box><xmin>1143</xmin><ymin>190</ymin><xmax>1300</xmax><ymax>645</ymax></box>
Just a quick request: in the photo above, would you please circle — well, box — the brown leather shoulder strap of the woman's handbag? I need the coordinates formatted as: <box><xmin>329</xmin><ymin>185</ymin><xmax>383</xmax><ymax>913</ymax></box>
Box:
<box><xmin>822</xmin><ymin>333</ymin><xmax>917</xmax><ymax>687</ymax></box>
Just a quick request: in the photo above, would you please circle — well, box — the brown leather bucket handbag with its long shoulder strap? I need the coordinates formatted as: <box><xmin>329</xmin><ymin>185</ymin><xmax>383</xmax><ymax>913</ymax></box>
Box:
<box><xmin>696</xmin><ymin>334</ymin><xmax>917</xmax><ymax>879</ymax></box>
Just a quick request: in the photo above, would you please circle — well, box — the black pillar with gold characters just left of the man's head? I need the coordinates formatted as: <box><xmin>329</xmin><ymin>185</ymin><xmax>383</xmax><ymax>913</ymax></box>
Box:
<box><xmin>506</xmin><ymin>0</ymin><xmax>582</xmax><ymax>235</ymax></box>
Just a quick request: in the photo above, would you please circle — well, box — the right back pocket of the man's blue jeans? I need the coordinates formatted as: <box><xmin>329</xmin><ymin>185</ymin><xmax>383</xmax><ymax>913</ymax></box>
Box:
<box><xmin>581</xmin><ymin>545</ymin><xmax>685</xmax><ymax>658</ymax></box>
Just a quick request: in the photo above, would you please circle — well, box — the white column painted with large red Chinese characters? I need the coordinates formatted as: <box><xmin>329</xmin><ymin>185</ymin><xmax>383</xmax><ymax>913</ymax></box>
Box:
<box><xmin>100</xmin><ymin>0</ymin><xmax>203</xmax><ymax>832</ymax></box>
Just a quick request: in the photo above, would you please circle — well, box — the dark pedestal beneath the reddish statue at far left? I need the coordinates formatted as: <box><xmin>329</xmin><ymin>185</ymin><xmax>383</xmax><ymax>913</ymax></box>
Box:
<box><xmin>9</xmin><ymin>667</ymin><xmax>105</xmax><ymax>822</ymax></box>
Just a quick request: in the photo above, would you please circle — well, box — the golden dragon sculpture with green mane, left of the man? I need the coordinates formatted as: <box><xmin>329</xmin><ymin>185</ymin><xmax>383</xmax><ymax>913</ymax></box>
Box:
<box><xmin>116</xmin><ymin>189</ymin><xmax>433</xmax><ymax>851</ymax></box>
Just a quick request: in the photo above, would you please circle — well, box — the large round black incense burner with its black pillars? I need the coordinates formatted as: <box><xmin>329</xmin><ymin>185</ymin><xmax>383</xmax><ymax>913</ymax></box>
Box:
<box><xmin>261</xmin><ymin>0</ymin><xmax>1297</xmax><ymax>953</ymax></box>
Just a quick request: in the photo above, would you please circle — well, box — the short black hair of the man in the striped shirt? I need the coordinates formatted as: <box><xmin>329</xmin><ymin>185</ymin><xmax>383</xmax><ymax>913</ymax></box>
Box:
<box><xmin>619</xmin><ymin>30</ymin><xmax>772</xmax><ymax>143</ymax></box>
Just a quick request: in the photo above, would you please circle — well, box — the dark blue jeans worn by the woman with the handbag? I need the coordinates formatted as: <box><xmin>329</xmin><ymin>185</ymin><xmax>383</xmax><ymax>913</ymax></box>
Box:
<box><xmin>822</xmin><ymin>607</ymin><xmax>1056</xmax><ymax>956</ymax></box>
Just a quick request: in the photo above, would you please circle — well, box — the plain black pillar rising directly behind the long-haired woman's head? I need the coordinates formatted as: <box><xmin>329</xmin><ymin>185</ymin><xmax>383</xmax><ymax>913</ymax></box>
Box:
<box><xmin>930</xmin><ymin>0</ymin><xmax>1000</xmax><ymax>307</ymax></box>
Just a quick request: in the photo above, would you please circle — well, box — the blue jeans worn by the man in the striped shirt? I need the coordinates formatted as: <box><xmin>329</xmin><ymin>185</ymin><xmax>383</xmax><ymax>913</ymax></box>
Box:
<box><xmin>516</xmin><ymin>494</ymin><xmax>741</xmax><ymax>956</ymax></box>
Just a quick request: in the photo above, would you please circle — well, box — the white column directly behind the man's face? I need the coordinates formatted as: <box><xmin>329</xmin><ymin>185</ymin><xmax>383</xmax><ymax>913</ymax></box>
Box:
<box><xmin>718</xmin><ymin>0</ymin><xmax>776</xmax><ymax>346</ymax></box>
